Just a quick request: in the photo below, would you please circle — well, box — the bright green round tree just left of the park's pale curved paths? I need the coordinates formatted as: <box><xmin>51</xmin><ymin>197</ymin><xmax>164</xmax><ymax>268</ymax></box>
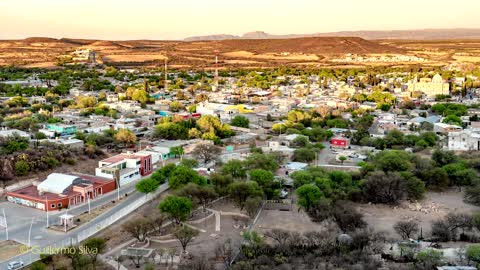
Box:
<box><xmin>158</xmin><ymin>195</ymin><xmax>192</xmax><ymax>224</ymax></box>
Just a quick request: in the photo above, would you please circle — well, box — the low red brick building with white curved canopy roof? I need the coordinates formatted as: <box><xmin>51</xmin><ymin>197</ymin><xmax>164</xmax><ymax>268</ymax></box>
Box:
<box><xmin>7</xmin><ymin>173</ymin><xmax>116</xmax><ymax>211</ymax></box>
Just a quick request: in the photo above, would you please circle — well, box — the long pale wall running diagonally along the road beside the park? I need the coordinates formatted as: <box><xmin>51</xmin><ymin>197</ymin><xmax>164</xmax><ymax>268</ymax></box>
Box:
<box><xmin>0</xmin><ymin>184</ymin><xmax>168</xmax><ymax>270</ymax></box>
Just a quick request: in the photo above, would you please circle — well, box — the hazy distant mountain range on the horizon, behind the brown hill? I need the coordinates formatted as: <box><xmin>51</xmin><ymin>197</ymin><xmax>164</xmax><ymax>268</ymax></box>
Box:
<box><xmin>184</xmin><ymin>28</ymin><xmax>480</xmax><ymax>41</ymax></box>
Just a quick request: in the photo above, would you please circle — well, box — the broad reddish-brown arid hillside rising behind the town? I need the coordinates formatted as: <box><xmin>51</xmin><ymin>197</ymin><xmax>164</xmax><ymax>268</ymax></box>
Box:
<box><xmin>0</xmin><ymin>35</ymin><xmax>464</xmax><ymax>69</ymax></box>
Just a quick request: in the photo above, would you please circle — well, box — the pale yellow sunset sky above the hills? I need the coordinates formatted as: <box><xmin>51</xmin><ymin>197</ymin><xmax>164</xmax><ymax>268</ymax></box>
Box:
<box><xmin>0</xmin><ymin>0</ymin><xmax>480</xmax><ymax>40</ymax></box>
